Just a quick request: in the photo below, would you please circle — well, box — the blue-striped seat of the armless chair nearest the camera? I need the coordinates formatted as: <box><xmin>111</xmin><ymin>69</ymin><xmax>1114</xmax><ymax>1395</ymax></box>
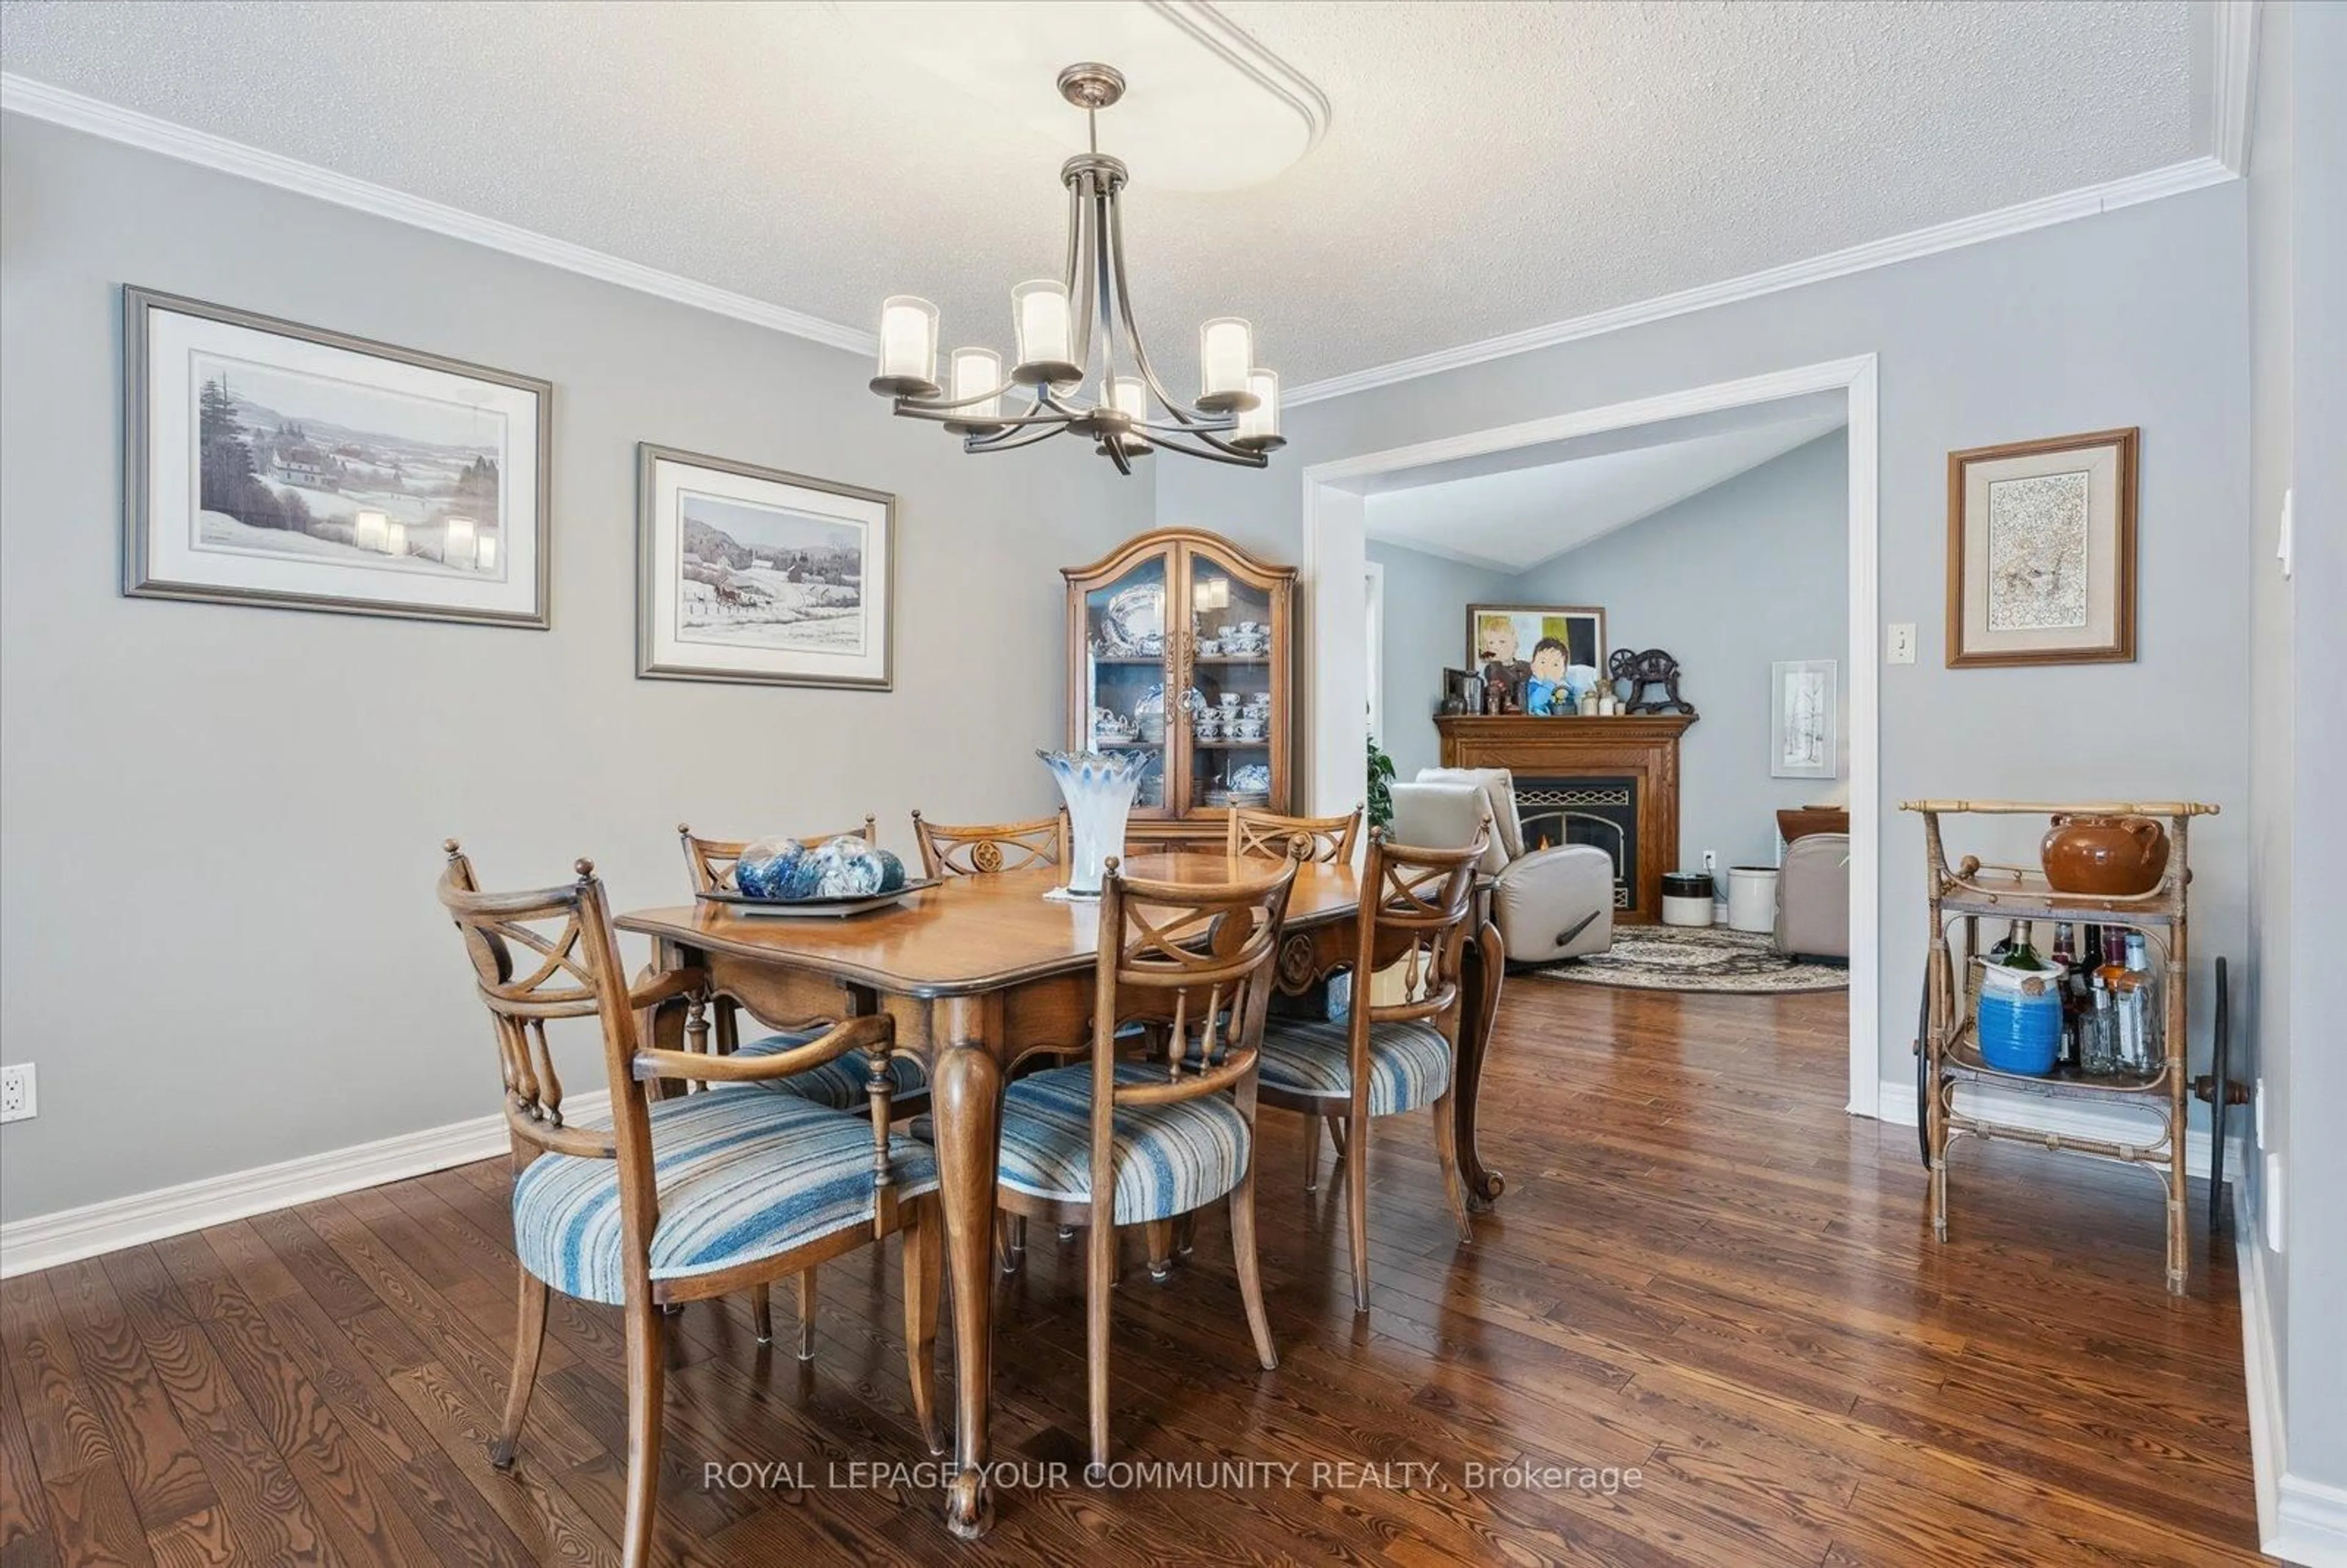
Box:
<box><xmin>1002</xmin><ymin>1061</ymin><xmax>1254</xmax><ymax>1225</ymax></box>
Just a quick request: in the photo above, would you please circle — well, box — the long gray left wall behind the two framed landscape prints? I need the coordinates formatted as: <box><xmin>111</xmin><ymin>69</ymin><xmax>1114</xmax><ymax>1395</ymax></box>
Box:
<box><xmin>0</xmin><ymin>117</ymin><xmax>1152</xmax><ymax>1218</ymax></box>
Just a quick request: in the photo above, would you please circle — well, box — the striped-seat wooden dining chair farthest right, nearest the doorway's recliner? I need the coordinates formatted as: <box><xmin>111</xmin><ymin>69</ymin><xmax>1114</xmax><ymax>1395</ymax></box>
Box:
<box><xmin>1260</xmin><ymin>831</ymin><xmax>1483</xmax><ymax>1312</ymax></box>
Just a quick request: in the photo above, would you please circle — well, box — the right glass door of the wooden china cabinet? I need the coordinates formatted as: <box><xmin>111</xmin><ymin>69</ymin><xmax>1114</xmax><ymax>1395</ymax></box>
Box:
<box><xmin>1178</xmin><ymin>544</ymin><xmax>1288</xmax><ymax>810</ymax></box>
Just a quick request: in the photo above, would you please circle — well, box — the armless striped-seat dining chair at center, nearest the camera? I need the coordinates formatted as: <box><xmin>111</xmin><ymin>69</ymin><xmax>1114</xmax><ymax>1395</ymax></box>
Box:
<box><xmin>997</xmin><ymin>859</ymin><xmax>1296</xmax><ymax>1474</ymax></box>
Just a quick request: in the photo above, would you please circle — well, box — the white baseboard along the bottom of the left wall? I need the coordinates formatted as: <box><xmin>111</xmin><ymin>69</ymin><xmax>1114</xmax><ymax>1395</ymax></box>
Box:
<box><xmin>0</xmin><ymin>1089</ymin><xmax>610</xmax><ymax>1280</ymax></box>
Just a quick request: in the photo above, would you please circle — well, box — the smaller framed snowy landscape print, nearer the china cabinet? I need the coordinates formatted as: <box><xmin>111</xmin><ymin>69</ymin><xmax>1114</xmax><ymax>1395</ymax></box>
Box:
<box><xmin>636</xmin><ymin>444</ymin><xmax>897</xmax><ymax>690</ymax></box>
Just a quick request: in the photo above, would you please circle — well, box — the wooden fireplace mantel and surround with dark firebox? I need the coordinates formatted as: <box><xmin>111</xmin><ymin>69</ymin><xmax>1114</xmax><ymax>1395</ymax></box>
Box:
<box><xmin>1434</xmin><ymin>714</ymin><xmax>1694</xmax><ymax>925</ymax></box>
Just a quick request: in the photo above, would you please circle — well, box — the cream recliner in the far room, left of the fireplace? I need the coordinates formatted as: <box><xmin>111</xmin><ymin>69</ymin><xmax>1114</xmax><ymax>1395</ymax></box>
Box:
<box><xmin>1394</xmin><ymin>768</ymin><xmax>1612</xmax><ymax>965</ymax></box>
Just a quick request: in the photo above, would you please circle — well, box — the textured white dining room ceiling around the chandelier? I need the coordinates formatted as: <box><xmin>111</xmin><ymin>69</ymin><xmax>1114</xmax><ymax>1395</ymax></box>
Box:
<box><xmin>0</xmin><ymin>0</ymin><xmax>2206</xmax><ymax>385</ymax></box>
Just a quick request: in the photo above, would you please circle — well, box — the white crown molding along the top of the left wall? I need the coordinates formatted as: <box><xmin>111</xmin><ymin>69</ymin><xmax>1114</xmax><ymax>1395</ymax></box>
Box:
<box><xmin>0</xmin><ymin>70</ymin><xmax>878</xmax><ymax>354</ymax></box>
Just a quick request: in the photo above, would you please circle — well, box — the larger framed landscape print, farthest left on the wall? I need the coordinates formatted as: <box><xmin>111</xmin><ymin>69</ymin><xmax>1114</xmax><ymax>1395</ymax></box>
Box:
<box><xmin>122</xmin><ymin>288</ymin><xmax>554</xmax><ymax>631</ymax></box>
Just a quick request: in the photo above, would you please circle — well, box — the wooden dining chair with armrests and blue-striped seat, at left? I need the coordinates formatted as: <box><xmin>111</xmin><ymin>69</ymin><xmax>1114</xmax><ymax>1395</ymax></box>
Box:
<box><xmin>439</xmin><ymin>838</ymin><xmax>944</xmax><ymax>1568</ymax></box>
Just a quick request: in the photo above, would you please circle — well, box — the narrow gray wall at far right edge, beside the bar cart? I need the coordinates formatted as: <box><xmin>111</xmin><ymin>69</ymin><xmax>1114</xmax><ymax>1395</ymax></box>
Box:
<box><xmin>2244</xmin><ymin>5</ymin><xmax>2347</xmax><ymax>1502</ymax></box>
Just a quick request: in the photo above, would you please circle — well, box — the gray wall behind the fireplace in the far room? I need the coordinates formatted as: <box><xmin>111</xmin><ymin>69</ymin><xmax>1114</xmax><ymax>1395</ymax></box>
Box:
<box><xmin>1507</xmin><ymin>432</ymin><xmax>1849</xmax><ymax>868</ymax></box>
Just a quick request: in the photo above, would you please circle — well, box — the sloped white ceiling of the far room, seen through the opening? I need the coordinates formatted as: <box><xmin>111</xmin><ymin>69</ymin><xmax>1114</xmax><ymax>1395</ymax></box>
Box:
<box><xmin>1364</xmin><ymin>397</ymin><xmax>1849</xmax><ymax>573</ymax></box>
